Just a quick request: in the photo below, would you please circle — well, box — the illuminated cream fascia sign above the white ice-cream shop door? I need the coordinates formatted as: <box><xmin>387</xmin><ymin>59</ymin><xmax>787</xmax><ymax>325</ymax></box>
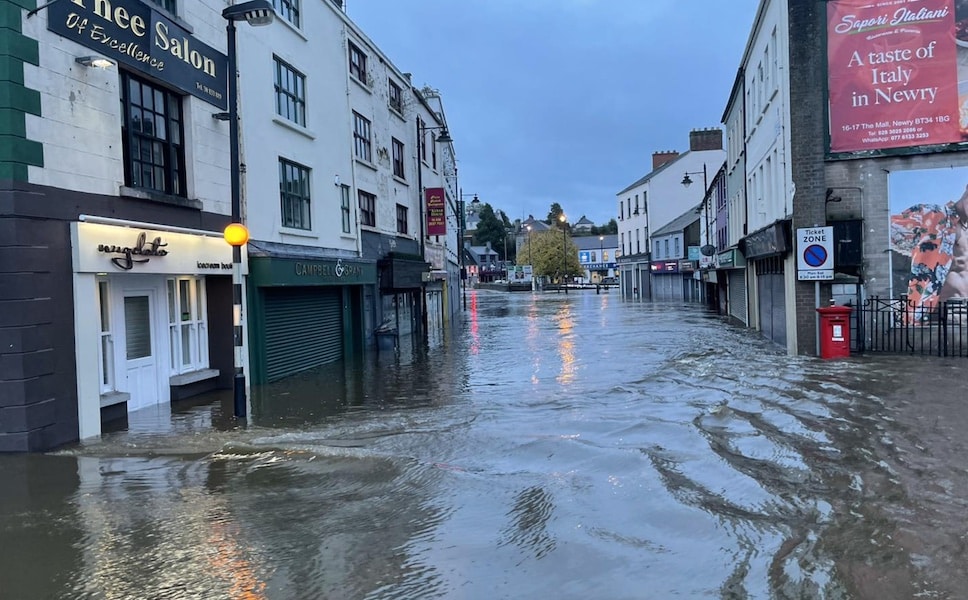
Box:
<box><xmin>71</xmin><ymin>222</ymin><xmax>233</xmax><ymax>275</ymax></box>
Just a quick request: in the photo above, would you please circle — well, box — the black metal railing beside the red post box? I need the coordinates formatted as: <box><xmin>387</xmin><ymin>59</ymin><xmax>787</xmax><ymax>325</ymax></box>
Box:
<box><xmin>851</xmin><ymin>296</ymin><xmax>968</xmax><ymax>356</ymax></box>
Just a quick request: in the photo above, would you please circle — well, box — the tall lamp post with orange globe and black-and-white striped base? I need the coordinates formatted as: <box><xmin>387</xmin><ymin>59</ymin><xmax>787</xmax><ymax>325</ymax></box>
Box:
<box><xmin>221</xmin><ymin>0</ymin><xmax>275</xmax><ymax>418</ymax></box>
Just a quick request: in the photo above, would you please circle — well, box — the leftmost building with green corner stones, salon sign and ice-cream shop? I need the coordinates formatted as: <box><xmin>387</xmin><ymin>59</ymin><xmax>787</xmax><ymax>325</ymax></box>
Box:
<box><xmin>0</xmin><ymin>0</ymin><xmax>240</xmax><ymax>451</ymax></box>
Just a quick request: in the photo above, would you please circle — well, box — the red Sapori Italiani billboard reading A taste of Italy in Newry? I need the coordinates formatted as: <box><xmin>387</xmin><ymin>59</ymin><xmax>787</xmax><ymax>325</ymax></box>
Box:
<box><xmin>827</xmin><ymin>0</ymin><xmax>968</xmax><ymax>153</ymax></box>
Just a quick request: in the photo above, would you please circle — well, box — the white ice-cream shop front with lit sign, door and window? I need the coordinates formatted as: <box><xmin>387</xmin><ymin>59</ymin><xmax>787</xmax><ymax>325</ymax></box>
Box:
<box><xmin>71</xmin><ymin>217</ymin><xmax>233</xmax><ymax>438</ymax></box>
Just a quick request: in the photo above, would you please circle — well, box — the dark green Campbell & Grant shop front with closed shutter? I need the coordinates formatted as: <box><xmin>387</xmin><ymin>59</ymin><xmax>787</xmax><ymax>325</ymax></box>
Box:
<box><xmin>248</xmin><ymin>256</ymin><xmax>377</xmax><ymax>384</ymax></box>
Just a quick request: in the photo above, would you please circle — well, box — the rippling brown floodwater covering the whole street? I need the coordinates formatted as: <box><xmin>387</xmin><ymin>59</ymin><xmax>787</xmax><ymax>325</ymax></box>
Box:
<box><xmin>0</xmin><ymin>291</ymin><xmax>968</xmax><ymax>600</ymax></box>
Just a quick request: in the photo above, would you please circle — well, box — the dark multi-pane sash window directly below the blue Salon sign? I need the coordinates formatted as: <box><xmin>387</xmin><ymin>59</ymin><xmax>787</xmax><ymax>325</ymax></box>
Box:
<box><xmin>121</xmin><ymin>71</ymin><xmax>186</xmax><ymax>196</ymax></box>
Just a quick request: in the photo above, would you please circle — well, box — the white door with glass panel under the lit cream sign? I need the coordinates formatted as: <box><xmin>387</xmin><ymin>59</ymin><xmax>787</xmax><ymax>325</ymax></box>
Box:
<box><xmin>124</xmin><ymin>290</ymin><xmax>161</xmax><ymax>412</ymax></box>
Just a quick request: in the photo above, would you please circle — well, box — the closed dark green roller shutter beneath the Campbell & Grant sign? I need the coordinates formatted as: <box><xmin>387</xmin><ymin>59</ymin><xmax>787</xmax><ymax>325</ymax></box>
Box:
<box><xmin>265</xmin><ymin>287</ymin><xmax>343</xmax><ymax>381</ymax></box>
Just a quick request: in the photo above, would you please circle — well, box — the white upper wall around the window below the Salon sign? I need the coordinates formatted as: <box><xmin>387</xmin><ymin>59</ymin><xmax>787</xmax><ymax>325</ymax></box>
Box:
<box><xmin>23</xmin><ymin>0</ymin><xmax>229</xmax><ymax>214</ymax></box>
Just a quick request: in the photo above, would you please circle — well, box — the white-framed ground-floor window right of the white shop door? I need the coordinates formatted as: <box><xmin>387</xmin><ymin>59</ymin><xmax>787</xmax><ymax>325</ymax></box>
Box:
<box><xmin>167</xmin><ymin>277</ymin><xmax>208</xmax><ymax>375</ymax></box>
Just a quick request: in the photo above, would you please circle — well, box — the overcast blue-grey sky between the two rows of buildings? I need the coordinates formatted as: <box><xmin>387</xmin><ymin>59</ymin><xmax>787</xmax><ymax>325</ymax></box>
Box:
<box><xmin>345</xmin><ymin>0</ymin><xmax>759</xmax><ymax>224</ymax></box>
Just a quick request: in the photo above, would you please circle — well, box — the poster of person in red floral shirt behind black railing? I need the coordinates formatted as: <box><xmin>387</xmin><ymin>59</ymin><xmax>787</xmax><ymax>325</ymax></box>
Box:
<box><xmin>888</xmin><ymin>167</ymin><xmax>968</xmax><ymax>323</ymax></box>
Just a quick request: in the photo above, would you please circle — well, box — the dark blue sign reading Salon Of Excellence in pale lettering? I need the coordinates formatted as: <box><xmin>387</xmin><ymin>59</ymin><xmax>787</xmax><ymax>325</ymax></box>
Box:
<box><xmin>47</xmin><ymin>0</ymin><xmax>228</xmax><ymax>110</ymax></box>
